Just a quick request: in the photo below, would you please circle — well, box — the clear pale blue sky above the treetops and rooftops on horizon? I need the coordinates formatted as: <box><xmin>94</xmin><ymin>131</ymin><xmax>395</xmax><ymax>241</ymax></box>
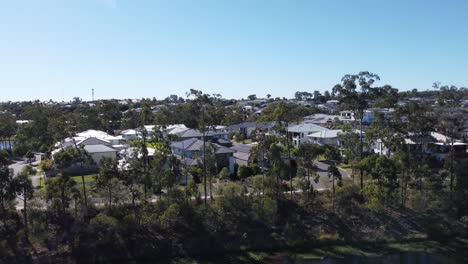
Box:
<box><xmin>0</xmin><ymin>0</ymin><xmax>468</xmax><ymax>101</ymax></box>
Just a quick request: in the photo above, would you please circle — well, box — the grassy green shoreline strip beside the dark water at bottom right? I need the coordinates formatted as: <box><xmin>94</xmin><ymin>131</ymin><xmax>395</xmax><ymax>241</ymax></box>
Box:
<box><xmin>175</xmin><ymin>238</ymin><xmax>468</xmax><ymax>263</ymax></box>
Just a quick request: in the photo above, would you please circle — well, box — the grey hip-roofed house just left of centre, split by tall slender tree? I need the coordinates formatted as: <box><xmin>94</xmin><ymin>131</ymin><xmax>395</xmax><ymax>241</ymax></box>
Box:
<box><xmin>171</xmin><ymin>138</ymin><xmax>235</xmax><ymax>173</ymax></box>
